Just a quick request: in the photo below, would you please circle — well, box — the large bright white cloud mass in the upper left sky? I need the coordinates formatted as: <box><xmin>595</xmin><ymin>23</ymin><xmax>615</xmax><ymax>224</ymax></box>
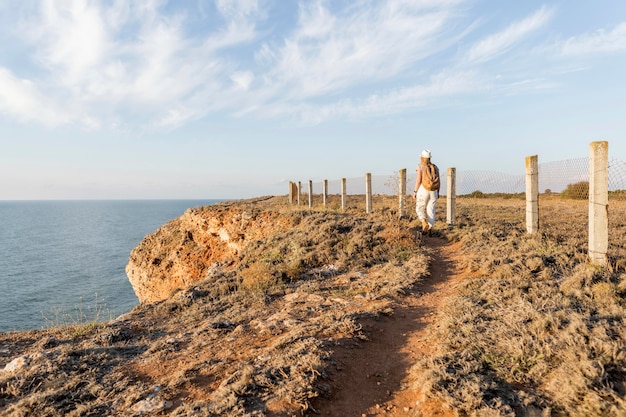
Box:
<box><xmin>5</xmin><ymin>0</ymin><xmax>262</xmax><ymax>128</ymax></box>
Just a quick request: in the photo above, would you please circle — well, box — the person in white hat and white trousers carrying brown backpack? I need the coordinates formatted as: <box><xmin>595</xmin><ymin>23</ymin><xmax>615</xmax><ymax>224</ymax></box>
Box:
<box><xmin>413</xmin><ymin>149</ymin><xmax>441</xmax><ymax>236</ymax></box>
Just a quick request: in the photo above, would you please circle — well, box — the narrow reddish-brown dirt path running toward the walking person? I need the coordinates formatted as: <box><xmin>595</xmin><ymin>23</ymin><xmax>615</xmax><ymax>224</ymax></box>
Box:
<box><xmin>308</xmin><ymin>237</ymin><xmax>464</xmax><ymax>417</ymax></box>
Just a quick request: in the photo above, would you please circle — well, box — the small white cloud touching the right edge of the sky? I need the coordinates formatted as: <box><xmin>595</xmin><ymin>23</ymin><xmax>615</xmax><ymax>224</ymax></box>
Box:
<box><xmin>562</xmin><ymin>22</ymin><xmax>626</xmax><ymax>55</ymax></box>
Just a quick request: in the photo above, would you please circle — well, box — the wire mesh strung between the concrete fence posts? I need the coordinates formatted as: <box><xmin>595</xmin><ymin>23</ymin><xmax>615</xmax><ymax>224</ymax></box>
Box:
<box><xmin>292</xmin><ymin>154</ymin><xmax>626</xmax><ymax>269</ymax></box>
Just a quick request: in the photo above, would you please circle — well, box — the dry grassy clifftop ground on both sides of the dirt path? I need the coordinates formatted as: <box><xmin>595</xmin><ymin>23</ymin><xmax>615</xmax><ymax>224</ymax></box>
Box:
<box><xmin>0</xmin><ymin>196</ymin><xmax>626</xmax><ymax>416</ymax></box>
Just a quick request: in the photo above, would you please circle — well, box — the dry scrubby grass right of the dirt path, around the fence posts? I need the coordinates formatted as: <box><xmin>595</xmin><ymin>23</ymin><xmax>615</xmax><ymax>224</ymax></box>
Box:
<box><xmin>412</xmin><ymin>199</ymin><xmax>626</xmax><ymax>416</ymax></box>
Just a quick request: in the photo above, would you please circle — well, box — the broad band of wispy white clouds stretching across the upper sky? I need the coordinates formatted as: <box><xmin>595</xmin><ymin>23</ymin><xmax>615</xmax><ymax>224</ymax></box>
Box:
<box><xmin>0</xmin><ymin>0</ymin><xmax>626</xmax><ymax>129</ymax></box>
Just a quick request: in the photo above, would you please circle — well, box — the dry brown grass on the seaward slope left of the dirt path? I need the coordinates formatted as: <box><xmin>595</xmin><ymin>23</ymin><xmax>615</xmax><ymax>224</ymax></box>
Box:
<box><xmin>0</xmin><ymin>197</ymin><xmax>427</xmax><ymax>416</ymax></box>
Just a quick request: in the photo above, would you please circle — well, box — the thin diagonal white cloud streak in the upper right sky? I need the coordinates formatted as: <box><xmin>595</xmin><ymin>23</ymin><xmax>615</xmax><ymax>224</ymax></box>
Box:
<box><xmin>467</xmin><ymin>6</ymin><xmax>553</xmax><ymax>62</ymax></box>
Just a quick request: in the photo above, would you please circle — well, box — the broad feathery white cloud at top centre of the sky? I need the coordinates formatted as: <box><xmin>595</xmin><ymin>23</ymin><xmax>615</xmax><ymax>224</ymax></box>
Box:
<box><xmin>260</xmin><ymin>1</ymin><xmax>464</xmax><ymax>99</ymax></box>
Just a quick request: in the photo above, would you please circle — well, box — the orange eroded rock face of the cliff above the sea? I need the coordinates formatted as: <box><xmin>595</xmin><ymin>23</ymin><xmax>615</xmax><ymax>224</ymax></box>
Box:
<box><xmin>126</xmin><ymin>206</ymin><xmax>286</xmax><ymax>303</ymax></box>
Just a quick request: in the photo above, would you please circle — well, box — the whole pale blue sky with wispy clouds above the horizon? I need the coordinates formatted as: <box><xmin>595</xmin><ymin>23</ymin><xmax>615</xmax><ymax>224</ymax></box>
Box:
<box><xmin>0</xmin><ymin>0</ymin><xmax>626</xmax><ymax>200</ymax></box>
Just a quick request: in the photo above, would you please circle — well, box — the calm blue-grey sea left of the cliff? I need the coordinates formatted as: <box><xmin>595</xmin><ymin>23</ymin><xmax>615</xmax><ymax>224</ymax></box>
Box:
<box><xmin>0</xmin><ymin>200</ymin><xmax>222</xmax><ymax>332</ymax></box>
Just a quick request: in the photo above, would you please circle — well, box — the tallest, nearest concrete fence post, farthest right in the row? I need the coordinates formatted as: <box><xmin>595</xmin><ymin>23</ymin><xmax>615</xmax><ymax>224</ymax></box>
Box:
<box><xmin>589</xmin><ymin>142</ymin><xmax>609</xmax><ymax>266</ymax></box>
